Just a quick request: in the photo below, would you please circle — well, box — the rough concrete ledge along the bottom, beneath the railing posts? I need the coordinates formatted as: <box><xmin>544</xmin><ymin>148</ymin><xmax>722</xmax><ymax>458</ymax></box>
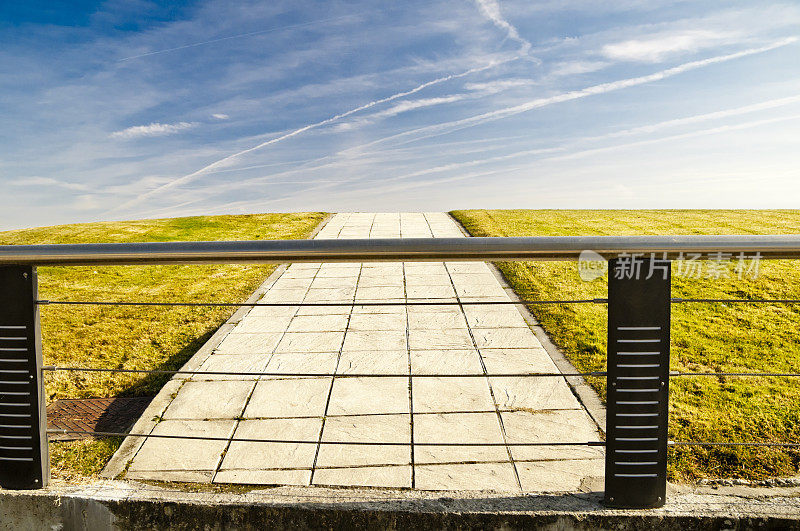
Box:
<box><xmin>0</xmin><ymin>481</ymin><xmax>800</xmax><ymax>531</ymax></box>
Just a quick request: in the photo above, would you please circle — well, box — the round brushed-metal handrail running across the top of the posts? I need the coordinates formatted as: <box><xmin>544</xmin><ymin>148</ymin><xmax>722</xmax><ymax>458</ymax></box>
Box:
<box><xmin>0</xmin><ymin>234</ymin><xmax>800</xmax><ymax>265</ymax></box>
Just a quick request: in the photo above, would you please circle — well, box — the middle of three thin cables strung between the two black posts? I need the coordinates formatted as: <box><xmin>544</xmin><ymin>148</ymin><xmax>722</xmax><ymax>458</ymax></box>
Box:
<box><xmin>42</xmin><ymin>365</ymin><xmax>606</xmax><ymax>378</ymax></box>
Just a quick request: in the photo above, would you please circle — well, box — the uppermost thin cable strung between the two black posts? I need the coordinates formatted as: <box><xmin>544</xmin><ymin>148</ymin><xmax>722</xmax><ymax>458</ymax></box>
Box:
<box><xmin>36</xmin><ymin>299</ymin><xmax>608</xmax><ymax>308</ymax></box>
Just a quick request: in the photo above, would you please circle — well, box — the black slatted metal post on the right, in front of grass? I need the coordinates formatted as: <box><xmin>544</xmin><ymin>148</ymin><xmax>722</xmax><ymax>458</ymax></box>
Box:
<box><xmin>605</xmin><ymin>256</ymin><xmax>671</xmax><ymax>508</ymax></box>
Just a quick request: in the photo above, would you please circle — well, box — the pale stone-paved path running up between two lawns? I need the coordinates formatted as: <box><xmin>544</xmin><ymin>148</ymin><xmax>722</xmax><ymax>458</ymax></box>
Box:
<box><xmin>128</xmin><ymin>213</ymin><xmax>603</xmax><ymax>494</ymax></box>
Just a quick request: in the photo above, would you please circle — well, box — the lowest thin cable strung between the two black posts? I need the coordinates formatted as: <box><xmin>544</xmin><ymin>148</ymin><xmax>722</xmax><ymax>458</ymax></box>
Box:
<box><xmin>47</xmin><ymin>429</ymin><xmax>606</xmax><ymax>447</ymax></box>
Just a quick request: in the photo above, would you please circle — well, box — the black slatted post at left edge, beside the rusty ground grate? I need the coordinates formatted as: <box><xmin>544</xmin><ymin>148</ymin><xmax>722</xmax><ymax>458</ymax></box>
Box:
<box><xmin>0</xmin><ymin>266</ymin><xmax>50</xmax><ymax>489</ymax></box>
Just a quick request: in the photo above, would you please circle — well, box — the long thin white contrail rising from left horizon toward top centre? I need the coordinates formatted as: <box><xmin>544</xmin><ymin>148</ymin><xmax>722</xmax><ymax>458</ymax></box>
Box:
<box><xmin>107</xmin><ymin>57</ymin><xmax>518</xmax><ymax>213</ymax></box>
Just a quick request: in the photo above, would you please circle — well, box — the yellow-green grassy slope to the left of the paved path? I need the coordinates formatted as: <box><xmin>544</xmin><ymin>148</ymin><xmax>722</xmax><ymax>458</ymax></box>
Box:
<box><xmin>0</xmin><ymin>213</ymin><xmax>325</xmax><ymax>478</ymax></box>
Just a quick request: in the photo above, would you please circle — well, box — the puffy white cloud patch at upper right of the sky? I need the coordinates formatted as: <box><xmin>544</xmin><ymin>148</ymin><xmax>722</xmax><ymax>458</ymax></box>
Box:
<box><xmin>600</xmin><ymin>30</ymin><xmax>735</xmax><ymax>63</ymax></box>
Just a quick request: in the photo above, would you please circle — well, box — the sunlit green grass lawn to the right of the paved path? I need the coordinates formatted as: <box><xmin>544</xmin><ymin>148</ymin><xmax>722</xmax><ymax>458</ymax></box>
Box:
<box><xmin>453</xmin><ymin>210</ymin><xmax>800</xmax><ymax>480</ymax></box>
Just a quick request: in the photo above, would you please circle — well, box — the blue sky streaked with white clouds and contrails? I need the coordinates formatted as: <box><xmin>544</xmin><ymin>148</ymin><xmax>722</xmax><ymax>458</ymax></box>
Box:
<box><xmin>0</xmin><ymin>0</ymin><xmax>800</xmax><ymax>229</ymax></box>
